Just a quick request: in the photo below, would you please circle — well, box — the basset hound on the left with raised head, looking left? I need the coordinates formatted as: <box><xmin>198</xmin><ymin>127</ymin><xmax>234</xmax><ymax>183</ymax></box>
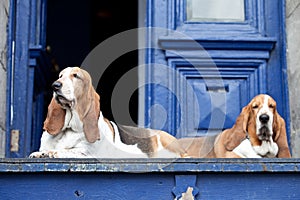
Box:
<box><xmin>29</xmin><ymin>67</ymin><xmax>186</xmax><ymax>158</ymax></box>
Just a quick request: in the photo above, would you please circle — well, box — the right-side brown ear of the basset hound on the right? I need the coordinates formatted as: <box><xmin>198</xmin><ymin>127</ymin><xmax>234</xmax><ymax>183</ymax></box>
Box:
<box><xmin>273</xmin><ymin>111</ymin><xmax>291</xmax><ymax>158</ymax></box>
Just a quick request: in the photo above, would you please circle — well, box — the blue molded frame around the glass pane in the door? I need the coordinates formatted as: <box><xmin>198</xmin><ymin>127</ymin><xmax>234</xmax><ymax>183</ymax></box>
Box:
<box><xmin>171</xmin><ymin>0</ymin><xmax>265</xmax><ymax>37</ymax></box>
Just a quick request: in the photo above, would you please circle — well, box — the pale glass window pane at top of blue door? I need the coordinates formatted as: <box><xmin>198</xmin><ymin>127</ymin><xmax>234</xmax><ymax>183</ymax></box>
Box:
<box><xmin>186</xmin><ymin>0</ymin><xmax>245</xmax><ymax>22</ymax></box>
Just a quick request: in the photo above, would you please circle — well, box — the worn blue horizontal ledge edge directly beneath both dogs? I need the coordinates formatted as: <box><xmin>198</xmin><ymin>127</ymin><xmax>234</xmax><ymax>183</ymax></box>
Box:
<box><xmin>0</xmin><ymin>158</ymin><xmax>300</xmax><ymax>175</ymax></box>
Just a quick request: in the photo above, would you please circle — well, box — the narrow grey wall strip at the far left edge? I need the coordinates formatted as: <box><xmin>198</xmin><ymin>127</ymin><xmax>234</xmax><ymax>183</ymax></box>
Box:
<box><xmin>0</xmin><ymin>0</ymin><xmax>9</xmax><ymax>158</ymax></box>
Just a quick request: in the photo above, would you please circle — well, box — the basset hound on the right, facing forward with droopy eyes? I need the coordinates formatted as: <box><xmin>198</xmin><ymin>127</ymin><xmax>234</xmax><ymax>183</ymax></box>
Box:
<box><xmin>179</xmin><ymin>94</ymin><xmax>291</xmax><ymax>158</ymax></box>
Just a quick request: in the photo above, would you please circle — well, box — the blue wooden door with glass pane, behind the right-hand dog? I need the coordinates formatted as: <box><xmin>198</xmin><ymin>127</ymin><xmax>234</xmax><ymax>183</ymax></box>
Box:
<box><xmin>145</xmin><ymin>0</ymin><xmax>289</xmax><ymax>137</ymax></box>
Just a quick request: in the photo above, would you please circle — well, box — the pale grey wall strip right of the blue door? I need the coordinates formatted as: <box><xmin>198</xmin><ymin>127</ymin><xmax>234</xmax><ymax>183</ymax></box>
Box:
<box><xmin>286</xmin><ymin>0</ymin><xmax>300</xmax><ymax>157</ymax></box>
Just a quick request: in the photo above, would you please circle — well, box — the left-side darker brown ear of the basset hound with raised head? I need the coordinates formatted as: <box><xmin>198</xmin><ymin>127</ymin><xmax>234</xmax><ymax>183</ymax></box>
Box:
<box><xmin>43</xmin><ymin>97</ymin><xmax>66</xmax><ymax>135</ymax></box>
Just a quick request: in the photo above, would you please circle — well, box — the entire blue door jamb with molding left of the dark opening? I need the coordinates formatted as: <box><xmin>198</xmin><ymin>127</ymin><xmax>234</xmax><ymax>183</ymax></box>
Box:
<box><xmin>6</xmin><ymin>0</ymin><xmax>51</xmax><ymax>157</ymax></box>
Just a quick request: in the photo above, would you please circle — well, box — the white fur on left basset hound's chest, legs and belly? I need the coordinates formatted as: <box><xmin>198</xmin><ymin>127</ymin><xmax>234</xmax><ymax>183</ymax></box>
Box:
<box><xmin>30</xmin><ymin>110</ymin><xmax>179</xmax><ymax>158</ymax></box>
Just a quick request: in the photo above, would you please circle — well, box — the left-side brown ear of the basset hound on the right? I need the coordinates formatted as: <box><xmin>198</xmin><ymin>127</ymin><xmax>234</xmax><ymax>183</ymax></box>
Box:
<box><xmin>224</xmin><ymin>105</ymin><xmax>250</xmax><ymax>151</ymax></box>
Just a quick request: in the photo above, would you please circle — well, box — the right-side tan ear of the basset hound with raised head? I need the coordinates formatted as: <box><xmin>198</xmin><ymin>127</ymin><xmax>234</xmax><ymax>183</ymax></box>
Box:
<box><xmin>82</xmin><ymin>86</ymin><xmax>100</xmax><ymax>143</ymax></box>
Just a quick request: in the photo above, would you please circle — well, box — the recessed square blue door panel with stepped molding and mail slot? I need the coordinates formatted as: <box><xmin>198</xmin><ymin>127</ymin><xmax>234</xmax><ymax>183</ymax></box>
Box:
<box><xmin>172</xmin><ymin>59</ymin><xmax>266</xmax><ymax>137</ymax></box>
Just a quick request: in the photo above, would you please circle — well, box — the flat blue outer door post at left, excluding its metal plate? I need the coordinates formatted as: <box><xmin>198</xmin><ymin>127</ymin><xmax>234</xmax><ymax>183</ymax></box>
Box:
<box><xmin>6</xmin><ymin>0</ymin><xmax>33</xmax><ymax>157</ymax></box>
